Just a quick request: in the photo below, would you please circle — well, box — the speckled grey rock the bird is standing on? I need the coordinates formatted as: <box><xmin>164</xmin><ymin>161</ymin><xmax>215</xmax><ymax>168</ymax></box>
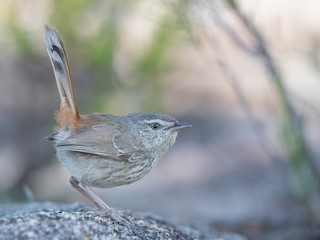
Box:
<box><xmin>0</xmin><ymin>203</ymin><xmax>245</xmax><ymax>240</ymax></box>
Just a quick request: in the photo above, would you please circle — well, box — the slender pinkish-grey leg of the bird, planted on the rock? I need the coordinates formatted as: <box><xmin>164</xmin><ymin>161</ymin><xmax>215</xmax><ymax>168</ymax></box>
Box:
<box><xmin>69</xmin><ymin>177</ymin><xmax>129</xmax><ymax>224</ymax></box>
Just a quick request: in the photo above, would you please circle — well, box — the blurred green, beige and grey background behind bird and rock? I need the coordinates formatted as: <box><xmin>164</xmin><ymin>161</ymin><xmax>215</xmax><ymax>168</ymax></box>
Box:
<box><xmin>0</xmin><ymin>0</ymin><xmax>320</xmax><ymax>239</ymax></box>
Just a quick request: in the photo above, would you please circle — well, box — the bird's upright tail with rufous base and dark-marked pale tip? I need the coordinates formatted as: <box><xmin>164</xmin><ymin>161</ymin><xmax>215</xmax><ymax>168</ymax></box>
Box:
<box><xmin>45</xmin><ymin>26</ymin><xmax>80</xmax><ymax>128</ymax></box>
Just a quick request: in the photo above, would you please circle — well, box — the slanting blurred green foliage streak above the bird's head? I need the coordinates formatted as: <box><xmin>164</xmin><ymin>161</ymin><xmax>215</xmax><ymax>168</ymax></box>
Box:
<box><xmin>134</xmin><ymin>0</ymin><xmax>194</xmax><ymax>111</ymax></box>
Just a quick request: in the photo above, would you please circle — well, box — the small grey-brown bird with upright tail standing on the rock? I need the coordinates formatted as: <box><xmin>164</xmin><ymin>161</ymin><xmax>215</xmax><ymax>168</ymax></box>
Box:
<box><xmin>45</xmin><ymin>26</ymin><xmax>191</xmax><ymax>221</ymax></box>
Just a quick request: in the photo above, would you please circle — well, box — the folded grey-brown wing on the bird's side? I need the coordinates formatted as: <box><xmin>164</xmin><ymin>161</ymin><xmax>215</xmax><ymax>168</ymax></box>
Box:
<box><xmin>56</xmin><ymin>124</ymin><xmax>145</xmax><ymax>162</ymax></box>
